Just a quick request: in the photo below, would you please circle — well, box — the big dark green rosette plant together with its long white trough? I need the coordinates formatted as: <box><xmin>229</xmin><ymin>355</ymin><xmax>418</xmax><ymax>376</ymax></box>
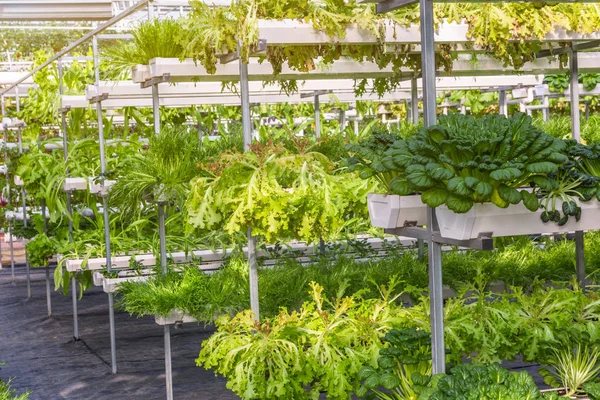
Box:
<box><xmin>356</xmin><ymin>114</ymin><xmax>600</xmax><ymax>239</ymax></box>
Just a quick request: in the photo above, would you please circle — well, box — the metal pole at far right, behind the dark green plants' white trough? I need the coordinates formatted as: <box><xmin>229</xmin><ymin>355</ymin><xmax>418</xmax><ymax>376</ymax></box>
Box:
<box><xmin>569</xmin><ymin>51</ymin><xmax>585</xmax><ymax>288</ymax></box>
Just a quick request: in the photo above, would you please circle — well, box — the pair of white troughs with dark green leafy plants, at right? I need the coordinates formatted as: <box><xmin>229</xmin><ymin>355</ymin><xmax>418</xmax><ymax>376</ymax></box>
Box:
<box><xmin>349</xmin><ymin>114</ymin><xmax>600</xmax><ymax>239</ymax></box>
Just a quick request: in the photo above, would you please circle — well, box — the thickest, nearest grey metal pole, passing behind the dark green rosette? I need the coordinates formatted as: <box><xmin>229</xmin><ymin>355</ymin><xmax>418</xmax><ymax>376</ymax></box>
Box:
<box><xmin>419</xmin><ymin>0</ymin><xmax>446</xmax><ymax>374</ymax></box>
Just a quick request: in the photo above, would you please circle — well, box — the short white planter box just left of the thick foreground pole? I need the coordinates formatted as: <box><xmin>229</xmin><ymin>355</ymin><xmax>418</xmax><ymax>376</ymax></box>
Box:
<box><xmin>367</xmin><ymin>193</ymin><xmax>427</xmax><ymax>229</ymax></box>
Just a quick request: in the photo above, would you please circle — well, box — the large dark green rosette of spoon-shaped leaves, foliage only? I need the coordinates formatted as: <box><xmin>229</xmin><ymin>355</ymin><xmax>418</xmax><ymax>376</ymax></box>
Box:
<box><xmin>382</xmin><ymin>114</ymin><xmax>567</xmax><ymax>213</ymax></box>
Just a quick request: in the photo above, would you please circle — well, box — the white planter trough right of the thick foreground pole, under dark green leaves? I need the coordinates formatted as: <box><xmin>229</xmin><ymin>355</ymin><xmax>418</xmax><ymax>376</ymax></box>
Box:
<box><xmin>436</xmin><ymin>200</ymin><xmax>600</xmax><ymax>240</ymax></box>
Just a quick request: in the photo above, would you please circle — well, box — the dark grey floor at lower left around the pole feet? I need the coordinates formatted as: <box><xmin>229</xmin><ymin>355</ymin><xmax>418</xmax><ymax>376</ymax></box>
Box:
<box><xmin>0</xmin><ymin>264</ymin><xmax>236</xmax><ymax>400</ymax></box>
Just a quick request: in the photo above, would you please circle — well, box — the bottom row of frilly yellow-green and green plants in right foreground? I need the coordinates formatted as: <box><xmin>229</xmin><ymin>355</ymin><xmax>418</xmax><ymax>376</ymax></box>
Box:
<box><xmin>197</xmin><ymin>280</ymin><xmax>600</xmax><ymax>400</ymax></box>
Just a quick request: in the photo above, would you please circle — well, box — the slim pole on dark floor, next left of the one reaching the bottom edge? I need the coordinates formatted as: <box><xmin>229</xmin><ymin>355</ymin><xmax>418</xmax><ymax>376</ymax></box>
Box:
<box><xmin>92</xmin><ymin>36</ymin><xmax>117</xmax><ymax>374</ymax></box>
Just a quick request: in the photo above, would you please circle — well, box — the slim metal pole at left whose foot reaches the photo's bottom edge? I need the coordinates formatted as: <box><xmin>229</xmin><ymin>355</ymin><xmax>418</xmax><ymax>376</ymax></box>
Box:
<box><xmin>152</xmin><ymin>80</ymin><xmax>173</xmax><ymax>400</ymax></box>
